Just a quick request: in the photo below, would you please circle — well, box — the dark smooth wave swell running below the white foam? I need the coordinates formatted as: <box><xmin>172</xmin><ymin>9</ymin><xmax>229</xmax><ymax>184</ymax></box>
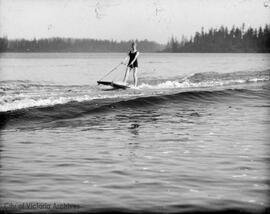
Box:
<box><xmin>0</xmin><ymin>89</ymin><xmax>269</xmax><ymax>127</ymax></box>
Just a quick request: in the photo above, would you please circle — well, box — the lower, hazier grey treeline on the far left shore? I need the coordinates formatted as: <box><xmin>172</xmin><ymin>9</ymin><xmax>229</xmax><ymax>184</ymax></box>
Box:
<box><xmin>0</xmin><ymin>38</ymin><xmax>164</xmax><ymax>52</ymax></box>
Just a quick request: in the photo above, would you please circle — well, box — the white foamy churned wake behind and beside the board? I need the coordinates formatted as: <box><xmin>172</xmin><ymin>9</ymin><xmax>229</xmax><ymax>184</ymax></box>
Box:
<box><xmin>0</xmin><ymin>70</ymin><xmax>270</xmax><ymax>112</ymax></box>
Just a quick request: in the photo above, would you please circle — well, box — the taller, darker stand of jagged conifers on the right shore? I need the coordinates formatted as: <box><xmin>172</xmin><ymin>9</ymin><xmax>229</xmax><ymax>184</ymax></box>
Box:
<box><xmin>164</xmin><ymin>24</ymin><xmax>270</xmax><ymax>53</ymax></box>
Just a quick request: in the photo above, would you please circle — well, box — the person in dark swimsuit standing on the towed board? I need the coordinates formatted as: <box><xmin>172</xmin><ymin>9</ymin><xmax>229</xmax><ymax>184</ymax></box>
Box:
<box><xmin>122</xmin><ymin>42</ymin><xmax>139</xmax><ymax>87</ymax></box>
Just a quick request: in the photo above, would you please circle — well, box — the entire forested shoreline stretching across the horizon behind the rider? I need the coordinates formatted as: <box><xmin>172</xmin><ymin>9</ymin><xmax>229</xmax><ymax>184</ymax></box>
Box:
<box><xmin>0</xmin><ymin>24</ymin><xmax>270</xmax><ymax>53</ymax></box>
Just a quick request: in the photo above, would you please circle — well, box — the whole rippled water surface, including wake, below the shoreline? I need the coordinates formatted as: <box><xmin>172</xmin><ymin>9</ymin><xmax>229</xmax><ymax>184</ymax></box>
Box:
<box><xmin>0</xmin><ymin>53</ymin><xmax>270</xmax><ymax>212</ymax></box>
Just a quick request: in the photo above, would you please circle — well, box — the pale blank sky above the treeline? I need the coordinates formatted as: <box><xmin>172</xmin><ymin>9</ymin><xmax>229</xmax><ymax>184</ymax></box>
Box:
<box><xmin>0</xmin><ymin>0</ymin><xmax>270</xmax><ymax>43</ymax></box>
